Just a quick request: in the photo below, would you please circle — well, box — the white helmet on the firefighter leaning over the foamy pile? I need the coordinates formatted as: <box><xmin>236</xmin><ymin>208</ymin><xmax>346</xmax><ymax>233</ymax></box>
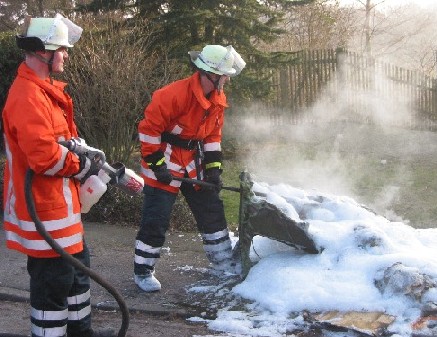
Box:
<box><xmin>188</xmin><ymin>45</ymin><xmax>246</xmax><ymax>76</ymax></box>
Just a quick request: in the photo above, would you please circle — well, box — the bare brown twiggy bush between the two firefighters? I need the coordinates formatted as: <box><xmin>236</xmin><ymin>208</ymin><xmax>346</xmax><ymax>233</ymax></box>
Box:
<box><xmin>63</xmin><ymin>19</ymin><xmax>181</xmax><ymax>163</ymax></box>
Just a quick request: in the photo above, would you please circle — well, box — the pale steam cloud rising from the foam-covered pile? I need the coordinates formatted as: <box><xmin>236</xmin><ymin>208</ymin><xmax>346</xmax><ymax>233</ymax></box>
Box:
<box><xmin>225</xmin><ymin>56</ymin><xmax>437</xmax><ymax>227</ymax></box>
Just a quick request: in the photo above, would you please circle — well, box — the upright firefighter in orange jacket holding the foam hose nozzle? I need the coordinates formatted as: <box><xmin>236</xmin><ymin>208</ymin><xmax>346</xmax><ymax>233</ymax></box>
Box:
<box><xmin>2</xmin><ymin>14</ymin><xmax>108</xmax><ymax>337</ymax></box>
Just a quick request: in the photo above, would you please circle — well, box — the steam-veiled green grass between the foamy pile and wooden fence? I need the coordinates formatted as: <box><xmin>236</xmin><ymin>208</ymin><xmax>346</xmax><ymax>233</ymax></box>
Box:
<box><xmin>221</xmin><ymin>138</ymin><xmax>437</xmax><ymax>229</ymax></box>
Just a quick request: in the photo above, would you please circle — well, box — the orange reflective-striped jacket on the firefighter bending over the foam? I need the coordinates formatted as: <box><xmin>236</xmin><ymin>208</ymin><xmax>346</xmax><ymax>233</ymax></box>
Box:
<box><xmin>138</xmin><ymin>72</ymin><xmax>228</xmax><ymax>193</ymax></box>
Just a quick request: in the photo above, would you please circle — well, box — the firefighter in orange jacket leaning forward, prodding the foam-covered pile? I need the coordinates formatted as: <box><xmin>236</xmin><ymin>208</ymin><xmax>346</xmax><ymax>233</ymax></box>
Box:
<box><xmin>134</xmin><ymin>45</ymin><xmax>245</xmax><ymax>292</ymax></box>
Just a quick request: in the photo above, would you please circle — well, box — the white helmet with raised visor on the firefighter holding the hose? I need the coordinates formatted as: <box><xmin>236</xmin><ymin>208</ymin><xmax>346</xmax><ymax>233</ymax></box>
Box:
<box><xmin>17</xmin><ymin>14</ymin><xmax>83</xmax><ymax>51</ymax></box>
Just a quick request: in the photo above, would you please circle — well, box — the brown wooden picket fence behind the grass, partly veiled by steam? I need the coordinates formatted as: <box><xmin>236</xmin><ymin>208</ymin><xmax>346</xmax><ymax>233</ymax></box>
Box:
<box><xmin>272</xmin><ymin>50</ymin><xmax>437</xmax><ymax>130</ymax></box>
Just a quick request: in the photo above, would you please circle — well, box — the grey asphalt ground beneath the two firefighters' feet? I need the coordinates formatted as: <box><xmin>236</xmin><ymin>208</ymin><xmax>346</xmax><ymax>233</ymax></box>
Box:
<box><xmin>0</xmin><ymin>223</ymin><xmax>238</xmax><ymax>337</ymax></box>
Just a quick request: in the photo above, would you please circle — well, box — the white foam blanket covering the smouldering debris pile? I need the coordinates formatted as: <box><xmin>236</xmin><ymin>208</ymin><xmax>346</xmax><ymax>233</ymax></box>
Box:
<box><xmin>189</xmin><ymin>182</ymin><xmax>437</xmax><ymax>337</ymax></box>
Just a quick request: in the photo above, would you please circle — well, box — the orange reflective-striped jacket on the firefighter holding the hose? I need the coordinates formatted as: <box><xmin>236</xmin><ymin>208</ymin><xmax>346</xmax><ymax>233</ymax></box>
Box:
<box><xmin>2</xmin><ymin>62</ymin><xmax>83</xmax><ymax>258</ymax></box>
